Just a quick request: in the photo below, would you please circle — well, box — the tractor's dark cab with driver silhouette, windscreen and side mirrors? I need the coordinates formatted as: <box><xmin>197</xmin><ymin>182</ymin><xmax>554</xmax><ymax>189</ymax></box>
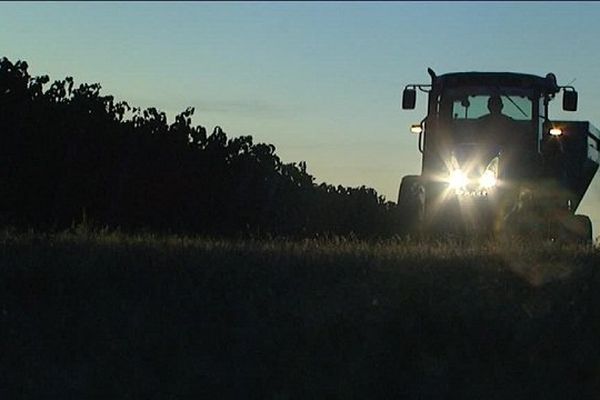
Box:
<box><xmin>404</xmin><ymin>70</ymin><xmax>577</xmax><ymax>183</ymax></box>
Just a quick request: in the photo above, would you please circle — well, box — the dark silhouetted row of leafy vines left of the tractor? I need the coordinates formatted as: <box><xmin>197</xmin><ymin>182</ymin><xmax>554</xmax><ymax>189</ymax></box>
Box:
<box><xmin>0</xmin><ymin>58</ymin><xmax>399</xmax><ymax>237</ymax></box>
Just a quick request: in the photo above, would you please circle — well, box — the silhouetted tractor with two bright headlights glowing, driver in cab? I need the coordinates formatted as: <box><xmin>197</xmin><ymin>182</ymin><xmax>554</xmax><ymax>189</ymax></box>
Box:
<box><xmin>398</xmin><ymin>68</ymin><xmax>600</xmax><ymax>242</ymax></box>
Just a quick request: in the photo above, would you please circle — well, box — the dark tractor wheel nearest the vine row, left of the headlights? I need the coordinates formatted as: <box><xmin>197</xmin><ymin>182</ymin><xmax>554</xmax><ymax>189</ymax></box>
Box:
<box><xmin>398</xmin><ymin>175</ymin><xmax>425</xmax><ymax>236</ymax></box>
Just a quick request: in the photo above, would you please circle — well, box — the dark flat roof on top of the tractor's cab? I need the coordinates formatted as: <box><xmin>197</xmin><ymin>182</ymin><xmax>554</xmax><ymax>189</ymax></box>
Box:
<box><xmin>434</xmin><ymin>72</ymin><xmax>559</xmax><ymax>93</ymax></box>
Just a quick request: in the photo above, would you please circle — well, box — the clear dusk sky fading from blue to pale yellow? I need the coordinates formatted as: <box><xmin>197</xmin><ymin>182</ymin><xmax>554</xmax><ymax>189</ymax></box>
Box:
<box><xmin>0</xmin><ymin>1</ymin><xmax>600</xmax><ymax>234</ymax></box>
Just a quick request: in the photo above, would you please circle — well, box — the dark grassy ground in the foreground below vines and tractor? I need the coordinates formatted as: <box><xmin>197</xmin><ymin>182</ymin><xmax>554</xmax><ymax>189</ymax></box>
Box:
<box><xmin>0</xmin><ymin>231</ymin><xmax>600</xmax><ymax>399</ymax></box>
